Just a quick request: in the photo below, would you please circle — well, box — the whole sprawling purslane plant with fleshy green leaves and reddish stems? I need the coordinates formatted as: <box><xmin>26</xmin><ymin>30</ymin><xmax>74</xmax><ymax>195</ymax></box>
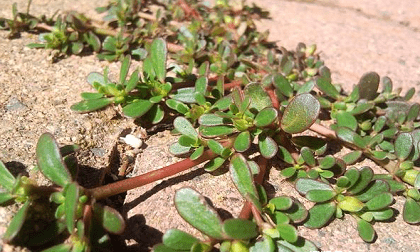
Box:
<box><xmin>0</xmin><ymin>0</ymin><xmax>420</xmax><ymax>252</ymax></box>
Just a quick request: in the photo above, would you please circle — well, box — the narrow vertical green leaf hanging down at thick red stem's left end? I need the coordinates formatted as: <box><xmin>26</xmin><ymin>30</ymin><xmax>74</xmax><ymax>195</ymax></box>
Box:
<box><xmin>64</xmin><ymin>182</ymin><xmax>79</xmax><ymax>234</ymax></box>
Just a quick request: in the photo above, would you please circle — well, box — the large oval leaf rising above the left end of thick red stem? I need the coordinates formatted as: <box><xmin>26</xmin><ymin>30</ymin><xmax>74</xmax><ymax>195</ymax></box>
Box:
<box><xmin>36</xmin><ymin>133</ymin><xmax>72</xmax><ymax>187</ymax></box>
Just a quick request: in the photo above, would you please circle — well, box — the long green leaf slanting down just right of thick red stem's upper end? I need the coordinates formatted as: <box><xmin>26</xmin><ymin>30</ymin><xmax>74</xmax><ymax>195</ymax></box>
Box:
<box><xmin>229</xmin><ymin>153</ymin><xmax>258</xmax><ymax>199</ymax></box>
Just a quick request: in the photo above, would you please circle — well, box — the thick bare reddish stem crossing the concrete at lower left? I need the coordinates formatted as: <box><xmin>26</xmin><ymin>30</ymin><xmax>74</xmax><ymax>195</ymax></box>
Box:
<box><xmin>88</xmin><ymin>150</ymin><xmax>217</xmax><ymax>199</ymax></box>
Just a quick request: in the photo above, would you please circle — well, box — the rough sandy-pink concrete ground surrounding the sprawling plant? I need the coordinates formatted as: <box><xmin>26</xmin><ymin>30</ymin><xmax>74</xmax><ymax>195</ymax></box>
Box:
<box><xmin>0</xmin><ymin>0</ymin><xmax>420</xmax><ymax>252</ymax></box>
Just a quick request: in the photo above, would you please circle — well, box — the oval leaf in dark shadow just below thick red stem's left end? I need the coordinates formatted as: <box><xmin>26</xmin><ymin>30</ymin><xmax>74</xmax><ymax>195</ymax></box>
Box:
<box><xmin>93</xmin><ymin>204</ymin><xmax>125</xmax><ymax>234</ymax></box>
